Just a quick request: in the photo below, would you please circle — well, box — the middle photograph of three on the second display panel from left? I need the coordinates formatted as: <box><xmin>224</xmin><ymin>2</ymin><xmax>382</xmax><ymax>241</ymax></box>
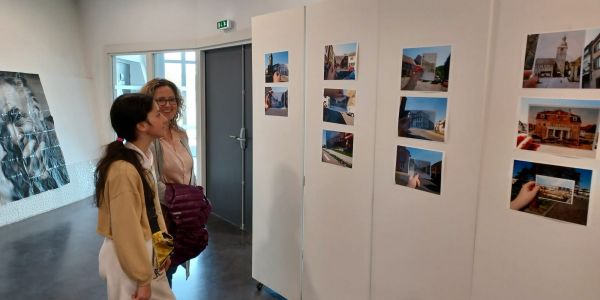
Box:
<box><xmin>323</xmin><ymin>89</ymin><xmax>356</xmax><ymax>125</ymax></box>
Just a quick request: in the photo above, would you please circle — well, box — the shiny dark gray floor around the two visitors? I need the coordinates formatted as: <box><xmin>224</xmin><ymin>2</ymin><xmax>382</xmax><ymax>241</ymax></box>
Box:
<box><xmin>0</xmin><ymin>199</ymin><xmax>285</xmax><ymax>300</ymax></box>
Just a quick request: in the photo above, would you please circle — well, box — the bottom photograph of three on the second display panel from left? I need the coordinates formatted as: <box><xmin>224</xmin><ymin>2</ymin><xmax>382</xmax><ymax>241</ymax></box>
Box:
<box><xmin>321</xmin><ymin>130</ymin><xmax>354</xmax><ymax>168</ymax></box>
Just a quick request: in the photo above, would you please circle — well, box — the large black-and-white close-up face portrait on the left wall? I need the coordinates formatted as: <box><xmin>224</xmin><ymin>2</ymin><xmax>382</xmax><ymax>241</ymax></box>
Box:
<box><xmin>0</xmin><ymin>71</ymin><xmax>70</xmax><ymax>205</ymax></box>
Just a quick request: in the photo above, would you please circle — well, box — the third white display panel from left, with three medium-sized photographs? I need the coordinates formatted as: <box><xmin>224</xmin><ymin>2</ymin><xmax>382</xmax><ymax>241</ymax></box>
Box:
<box><xmin>371</xmin><ymin>0</ymin><xmax>491</xmax><ymax>300</ymax></box>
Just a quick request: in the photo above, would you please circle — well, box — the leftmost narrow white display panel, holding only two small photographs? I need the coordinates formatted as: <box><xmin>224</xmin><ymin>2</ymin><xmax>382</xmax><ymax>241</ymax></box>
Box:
<box><xmin>252</xmin><ymin>7</ymin><xmax>304</xmax><ymax>300</ymax></box>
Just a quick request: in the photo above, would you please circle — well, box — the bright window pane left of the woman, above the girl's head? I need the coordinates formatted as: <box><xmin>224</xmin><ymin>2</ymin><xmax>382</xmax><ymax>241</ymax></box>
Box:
<box><xmin>112</xmin><ymin>54</ymin><xmax>148</xmax><ymax>98</ymax></box>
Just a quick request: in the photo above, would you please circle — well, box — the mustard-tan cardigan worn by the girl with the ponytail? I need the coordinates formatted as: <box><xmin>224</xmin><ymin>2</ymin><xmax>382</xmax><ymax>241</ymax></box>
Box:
<box><xmin>96</xmin><ymin>160</ymin><xmax>167</xmax><ymax>285</ymax></box>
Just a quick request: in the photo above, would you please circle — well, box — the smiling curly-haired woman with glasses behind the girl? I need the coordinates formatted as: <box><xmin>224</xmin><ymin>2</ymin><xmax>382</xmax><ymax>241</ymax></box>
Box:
<box><xmin>140</xmin><ymin>78</ymin><xmax>196</xmax><ymax>286</ymax></box>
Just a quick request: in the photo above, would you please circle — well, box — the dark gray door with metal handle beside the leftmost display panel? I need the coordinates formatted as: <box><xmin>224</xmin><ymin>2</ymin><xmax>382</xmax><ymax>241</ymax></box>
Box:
<box><xmin>204</xmin><ymin>45</ymin><xmax>252</xmax><ymax>229</ymax></box>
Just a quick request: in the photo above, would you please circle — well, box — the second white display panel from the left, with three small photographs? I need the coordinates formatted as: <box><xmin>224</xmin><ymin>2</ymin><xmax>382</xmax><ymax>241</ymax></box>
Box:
<box><xmin>302</xmin><ymin>0</ymin><xmax>378</xmax><ymax>300</ymax></box>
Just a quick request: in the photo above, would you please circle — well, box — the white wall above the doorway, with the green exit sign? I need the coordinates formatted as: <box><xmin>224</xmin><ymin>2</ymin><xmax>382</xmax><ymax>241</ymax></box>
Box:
<box><xmin>78</xmin><ymin>0</ymin><xmax>324</xmax><ymax>142</ymax></box>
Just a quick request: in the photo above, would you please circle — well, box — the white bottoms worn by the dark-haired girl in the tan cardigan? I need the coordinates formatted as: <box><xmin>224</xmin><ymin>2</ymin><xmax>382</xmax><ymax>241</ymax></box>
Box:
<box><xmin>98</xmin><ymin>238</ymin><xmax>175</xmax><ymax>300</ymax></box>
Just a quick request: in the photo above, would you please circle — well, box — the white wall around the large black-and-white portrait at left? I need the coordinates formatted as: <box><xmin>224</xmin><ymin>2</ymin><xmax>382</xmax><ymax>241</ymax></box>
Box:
<box><xmin>0</xmin><ymin>0</ymin><xmax>99</xmax><ymax>226</ymax></box>
